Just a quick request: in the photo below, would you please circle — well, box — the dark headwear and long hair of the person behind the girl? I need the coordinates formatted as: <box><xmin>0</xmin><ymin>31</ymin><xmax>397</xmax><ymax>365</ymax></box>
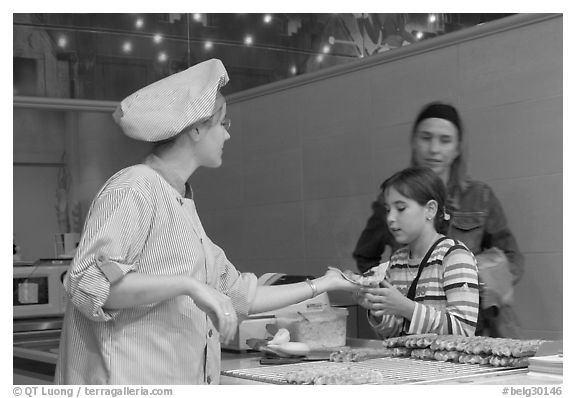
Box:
<box><xmin>410</xmin><ymin>102</ymin><xmax>468</xmax><ymax>192</ymax></box>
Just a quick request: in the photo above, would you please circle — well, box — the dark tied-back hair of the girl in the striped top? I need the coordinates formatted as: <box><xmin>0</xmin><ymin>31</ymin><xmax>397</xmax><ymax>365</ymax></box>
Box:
<box><xmin>380</xmin><ymin>166</ymin><xmax>448</xmax><ymax>233</ymax></box>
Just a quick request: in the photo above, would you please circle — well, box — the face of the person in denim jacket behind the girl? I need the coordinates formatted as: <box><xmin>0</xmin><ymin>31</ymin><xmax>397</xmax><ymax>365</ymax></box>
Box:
<box><xmin>412</xmin><ymin>118</ymin><xmax>460</xmax><ymax>180</ymax></box>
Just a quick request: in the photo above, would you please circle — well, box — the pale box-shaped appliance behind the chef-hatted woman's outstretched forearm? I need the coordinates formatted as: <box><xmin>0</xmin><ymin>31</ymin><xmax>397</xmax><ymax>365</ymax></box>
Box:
<box><xmin>222</xmin><ymin>273</ymin><xmax>330</xmax><ymax>351</ymax></box>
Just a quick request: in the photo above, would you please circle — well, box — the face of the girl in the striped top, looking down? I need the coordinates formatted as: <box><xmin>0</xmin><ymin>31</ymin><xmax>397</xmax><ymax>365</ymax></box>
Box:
<box><xmin>384</xmin><ymin>187</ymin><xmax>431</xmax><ymax>244</ymax></box>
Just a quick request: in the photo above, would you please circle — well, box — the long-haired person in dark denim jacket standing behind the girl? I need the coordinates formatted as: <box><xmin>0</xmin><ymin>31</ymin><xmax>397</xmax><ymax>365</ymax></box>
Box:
<box><xmin>354</xmin><ymin>102</ymin><xmax>524</xmax><ymax>338</ymax></box>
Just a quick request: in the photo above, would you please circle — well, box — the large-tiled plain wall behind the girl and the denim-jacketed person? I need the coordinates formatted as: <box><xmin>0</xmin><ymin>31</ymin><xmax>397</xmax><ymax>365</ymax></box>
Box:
<box><xmin>193</xmin><ymin>17</ymin><xmax>562</xmax><ymax>338</ymax></box>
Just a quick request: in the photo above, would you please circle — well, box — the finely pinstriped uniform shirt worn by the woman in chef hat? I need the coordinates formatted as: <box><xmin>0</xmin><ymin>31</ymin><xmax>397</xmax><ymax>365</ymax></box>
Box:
<box><xmin>55</xmin><ymin>155</ymin><xmax>256</xmax><ymax>384</ymax></box>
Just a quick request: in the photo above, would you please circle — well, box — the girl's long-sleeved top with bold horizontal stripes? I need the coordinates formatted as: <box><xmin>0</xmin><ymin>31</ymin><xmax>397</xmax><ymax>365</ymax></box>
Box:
<box><xmin>369</xmin><ymin>239</ymin><xmax>479</xmax><ymax>338</ymax></box>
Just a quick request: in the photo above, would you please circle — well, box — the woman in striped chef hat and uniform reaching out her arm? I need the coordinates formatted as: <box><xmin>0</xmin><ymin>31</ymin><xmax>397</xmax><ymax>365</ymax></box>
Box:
<box><xmin>55</xmin><ymin>59</ymin><xmax>354</xmax><ymax>384</ymax></box>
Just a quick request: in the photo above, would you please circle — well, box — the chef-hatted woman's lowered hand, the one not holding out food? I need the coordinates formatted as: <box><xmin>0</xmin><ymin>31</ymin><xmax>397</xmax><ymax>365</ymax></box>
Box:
<box><xmin>188</xmin><ymin>279</ymin><xmax>238</xmax><ymax>343</ymax></box>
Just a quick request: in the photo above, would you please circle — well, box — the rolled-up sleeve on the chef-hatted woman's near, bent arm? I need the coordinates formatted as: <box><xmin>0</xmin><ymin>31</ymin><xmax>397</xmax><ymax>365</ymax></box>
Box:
<box><xmin>64</xmin><ymin>188</ymin><xmax>152</xmax><ymax>322</ymax></box>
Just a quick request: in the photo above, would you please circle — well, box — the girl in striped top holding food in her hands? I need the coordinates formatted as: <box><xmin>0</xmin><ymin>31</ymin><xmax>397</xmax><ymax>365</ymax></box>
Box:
<box><xmin>359</xmin><ymin>167</ymin><xmax>479</xmax><ymax>338</ymax></box>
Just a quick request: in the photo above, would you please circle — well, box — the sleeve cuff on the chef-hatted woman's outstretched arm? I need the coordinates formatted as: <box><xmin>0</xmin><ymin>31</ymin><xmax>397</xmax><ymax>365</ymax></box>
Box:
<box><xmin>212</xmin><ymin>243</ymin><xmax>258</xmax><ymax>318</ymax></box>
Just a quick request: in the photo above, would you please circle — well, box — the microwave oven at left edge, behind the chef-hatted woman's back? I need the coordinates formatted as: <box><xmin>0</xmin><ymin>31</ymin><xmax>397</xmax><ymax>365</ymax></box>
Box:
<box><xmin>12</xmin><ymin>259</ymin><xmax>71</xmax><ymax>319</ymax></box>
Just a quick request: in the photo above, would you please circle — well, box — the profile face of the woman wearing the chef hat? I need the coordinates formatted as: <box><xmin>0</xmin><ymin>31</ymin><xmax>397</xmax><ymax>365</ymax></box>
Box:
<box><xmin>197</xmin><ymin>96</ymin><xmax>230</xmax><ymax>167</ymax></box>
